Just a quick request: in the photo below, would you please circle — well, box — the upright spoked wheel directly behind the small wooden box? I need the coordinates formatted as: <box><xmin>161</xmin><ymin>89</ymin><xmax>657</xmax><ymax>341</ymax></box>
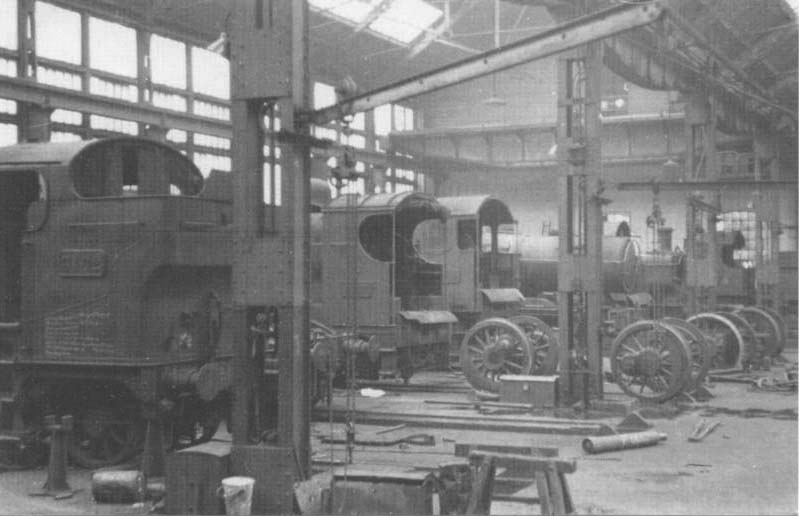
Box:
<box><xmin>461</xmin><ymin>317</ymin><xmax>533</xmax><ymax>392</ymax></box>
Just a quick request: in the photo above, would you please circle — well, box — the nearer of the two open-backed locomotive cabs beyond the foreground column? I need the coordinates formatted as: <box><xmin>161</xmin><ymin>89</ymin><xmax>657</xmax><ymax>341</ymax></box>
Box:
<box><xmin>322</xmin><ymin>192</ymin><xmax>457</xmax><ymax>379</ymax></box>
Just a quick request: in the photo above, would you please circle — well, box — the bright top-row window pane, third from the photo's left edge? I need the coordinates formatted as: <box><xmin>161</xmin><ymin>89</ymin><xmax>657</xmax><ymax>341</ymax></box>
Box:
<box><xmin>89</xmin><ymin>16</ymin><xmax>136</xmax><ymax>77</ymax></box>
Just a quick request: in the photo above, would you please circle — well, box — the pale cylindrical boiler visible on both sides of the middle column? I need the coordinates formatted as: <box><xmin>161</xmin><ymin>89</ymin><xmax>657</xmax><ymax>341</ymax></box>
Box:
<box><xmin>520</xmin><ymin>236</ymin><xmax>641</xmax><ymax>297</ymax></box>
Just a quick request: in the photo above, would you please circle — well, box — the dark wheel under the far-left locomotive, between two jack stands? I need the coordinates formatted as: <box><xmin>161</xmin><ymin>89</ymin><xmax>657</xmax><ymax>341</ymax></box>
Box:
<box><xmin>69</xmin><ymin>407</ymin><xmax>143</xmax><ymax>469</ymax></box>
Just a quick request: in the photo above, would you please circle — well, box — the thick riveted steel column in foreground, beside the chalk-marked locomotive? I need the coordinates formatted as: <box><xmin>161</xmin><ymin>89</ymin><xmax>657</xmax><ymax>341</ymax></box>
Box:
<box><xmin>230</xmin><ymin>0</ymin><xmax>310</xmax><ymax>513</ymax></box>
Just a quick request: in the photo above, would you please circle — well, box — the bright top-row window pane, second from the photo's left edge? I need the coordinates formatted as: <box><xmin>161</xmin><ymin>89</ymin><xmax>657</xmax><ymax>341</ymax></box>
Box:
<box><xmin>36</xmin><ymin>2</ymin><xmax>81</xmax><ymax>64</ymax></box>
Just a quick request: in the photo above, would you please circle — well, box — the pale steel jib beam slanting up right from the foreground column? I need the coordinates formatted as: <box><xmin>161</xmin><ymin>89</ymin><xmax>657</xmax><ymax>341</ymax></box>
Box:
<box><xmin>305</xmin><ymin>3</ymin><xmax>663</xmax><ymax>125</ymax></box>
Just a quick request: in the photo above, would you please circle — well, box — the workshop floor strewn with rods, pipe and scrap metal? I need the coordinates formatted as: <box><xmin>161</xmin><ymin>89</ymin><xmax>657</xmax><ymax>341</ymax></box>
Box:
<box><xmin>0</xmin><ymin>348</ymin><xmax>799</xmax><ymax>514</ymax></box>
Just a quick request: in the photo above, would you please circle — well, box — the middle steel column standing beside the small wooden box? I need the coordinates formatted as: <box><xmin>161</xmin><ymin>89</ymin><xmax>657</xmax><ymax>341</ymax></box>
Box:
<box><xmin>557</xmin><ymin>43</ymin><xmax>603</xmax><ymax>405</ymax></box>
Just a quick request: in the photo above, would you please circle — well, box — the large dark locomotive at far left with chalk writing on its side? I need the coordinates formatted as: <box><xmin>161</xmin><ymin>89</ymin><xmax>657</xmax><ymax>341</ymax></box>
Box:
<box><xmin>0</xmin><ymin>137</ymin><xmax>232</xmax><ymax>467</ymax></box>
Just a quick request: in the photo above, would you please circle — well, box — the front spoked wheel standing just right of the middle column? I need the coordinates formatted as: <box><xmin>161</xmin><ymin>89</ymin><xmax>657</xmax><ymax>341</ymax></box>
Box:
<box><xmin>610</xmin><ymin>321</ymin><xmax>691</xmax><ymax>402</ymax></box>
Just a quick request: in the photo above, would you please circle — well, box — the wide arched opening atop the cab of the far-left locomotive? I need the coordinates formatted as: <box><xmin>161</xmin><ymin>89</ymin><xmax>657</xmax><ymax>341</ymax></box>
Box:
<box><xmin>72</xmin><ymin>142</ymin><xmax>203</xmax><ymax>198</ymax></box>
